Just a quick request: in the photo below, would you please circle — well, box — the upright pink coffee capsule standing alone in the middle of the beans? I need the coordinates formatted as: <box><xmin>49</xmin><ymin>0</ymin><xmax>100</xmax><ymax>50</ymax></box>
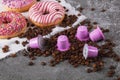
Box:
<box><xmin>57</xmin><ymin>35</ymin><xmax>70</xmax><ymax>51</ymax></box>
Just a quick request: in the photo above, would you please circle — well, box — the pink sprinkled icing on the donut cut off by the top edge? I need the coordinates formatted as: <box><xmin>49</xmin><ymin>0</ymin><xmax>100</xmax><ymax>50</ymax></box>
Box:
<box><xmin>2</xmin><ymin>0</ymin><xmax>36</xmax><ymax>8</ymax></box>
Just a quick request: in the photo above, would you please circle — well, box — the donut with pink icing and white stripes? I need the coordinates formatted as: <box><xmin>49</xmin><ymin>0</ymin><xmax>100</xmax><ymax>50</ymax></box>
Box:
<box><xmin>29</xmin><ymin>1</ymin><xmax>65</xmax><ymax>27</ymax></box>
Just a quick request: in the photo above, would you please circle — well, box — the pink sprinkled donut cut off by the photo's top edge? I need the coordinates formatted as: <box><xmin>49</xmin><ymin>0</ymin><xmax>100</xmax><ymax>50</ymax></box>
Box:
<box><xmin>2</xmin><ymin>0</ymin><xmax>37</xmax><ymax>12</ymax></box>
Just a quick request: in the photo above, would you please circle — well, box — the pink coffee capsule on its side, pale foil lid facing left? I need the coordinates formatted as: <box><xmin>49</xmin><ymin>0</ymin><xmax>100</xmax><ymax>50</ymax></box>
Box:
<box><xmin>83</xmin><ymin>44</ymin><xmax>98</xmax><ymax>59</ymax></box>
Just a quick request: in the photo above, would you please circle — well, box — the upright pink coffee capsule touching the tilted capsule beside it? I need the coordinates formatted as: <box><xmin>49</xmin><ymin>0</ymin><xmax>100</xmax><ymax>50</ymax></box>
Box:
<box><xmin>76</xmin><ymin>26</ymin><xmax>89</xmax><ymax>41</ymax></box>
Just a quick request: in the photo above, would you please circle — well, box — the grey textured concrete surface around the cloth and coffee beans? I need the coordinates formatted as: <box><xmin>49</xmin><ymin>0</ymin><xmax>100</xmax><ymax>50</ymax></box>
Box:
<box><xmin>0</xmin><ymin>0</ymin><xmax>120</xmax><ymax>80</ymax></box>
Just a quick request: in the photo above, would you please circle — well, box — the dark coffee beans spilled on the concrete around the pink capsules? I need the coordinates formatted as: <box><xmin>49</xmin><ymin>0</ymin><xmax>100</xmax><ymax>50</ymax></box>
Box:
<box><xmin>18</xmin><ymin>20</ymin><xmax>120</xmax><ymax>70</ymax></box>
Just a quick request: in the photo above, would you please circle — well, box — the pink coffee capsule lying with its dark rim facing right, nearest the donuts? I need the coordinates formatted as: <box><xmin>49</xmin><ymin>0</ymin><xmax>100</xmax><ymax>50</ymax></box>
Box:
<box><xmin>29</xmin><ymin>35</ymin><xmax>45</xmax><ymax>50</ymax></box>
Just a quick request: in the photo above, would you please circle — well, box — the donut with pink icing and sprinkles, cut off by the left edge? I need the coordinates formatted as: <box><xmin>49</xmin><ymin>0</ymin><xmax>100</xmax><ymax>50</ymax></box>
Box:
<box><xmin>0</xmin><ymin>11</ymin><xmax>27</xmax><ymax>39</ymax></box>
